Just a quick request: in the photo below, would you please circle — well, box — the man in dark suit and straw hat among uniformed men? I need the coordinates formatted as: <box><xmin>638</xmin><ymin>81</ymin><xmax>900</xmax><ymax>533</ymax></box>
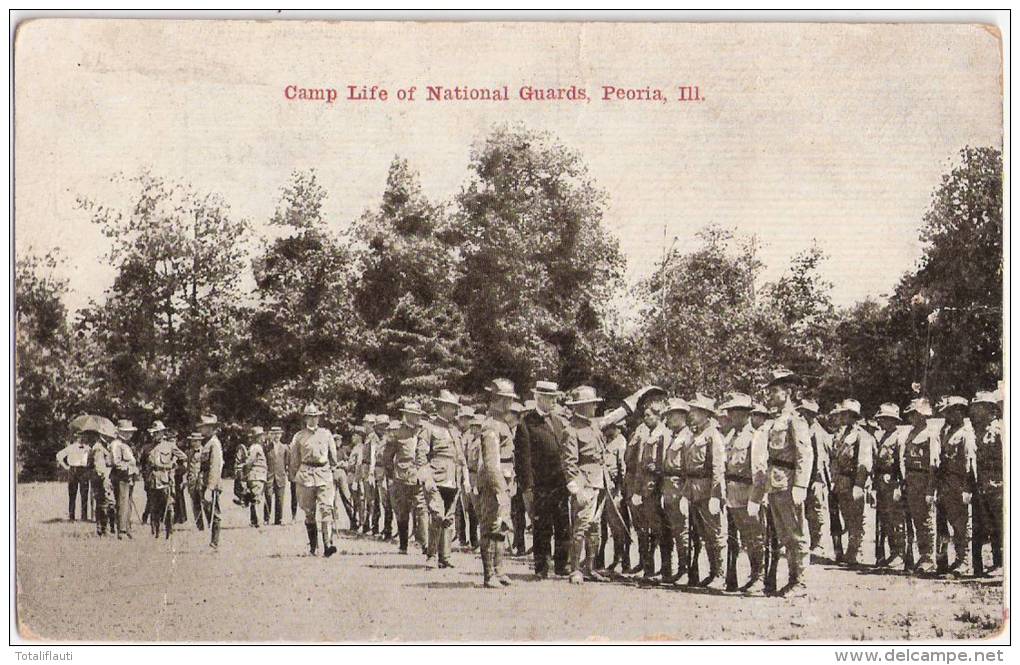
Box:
<box><xmin>515</xmin><ymin>381</ymin><xmax>570</xmax><ymax>579</ymax></box>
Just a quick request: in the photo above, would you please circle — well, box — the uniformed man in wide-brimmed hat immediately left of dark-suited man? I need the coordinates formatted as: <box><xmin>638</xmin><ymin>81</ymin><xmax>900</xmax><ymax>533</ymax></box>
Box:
<box><xmin>474</xmin><ymin>378</ymin><xmax>520</xmax><ymax>589</ymax></box>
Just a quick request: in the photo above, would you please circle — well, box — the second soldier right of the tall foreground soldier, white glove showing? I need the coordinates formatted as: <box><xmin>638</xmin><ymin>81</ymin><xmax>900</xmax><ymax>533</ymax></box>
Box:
<box><xmin>832</xmin><ymin>399</ymin><xmax>875</xmax><ymax>567</ymax></box>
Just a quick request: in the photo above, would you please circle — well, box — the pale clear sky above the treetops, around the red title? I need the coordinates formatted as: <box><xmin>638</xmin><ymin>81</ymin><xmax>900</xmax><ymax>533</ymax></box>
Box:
<box><xmin>15</xmin><ymin>20</ymin><xmax>1002</xmax><ymax>308</ymax></box>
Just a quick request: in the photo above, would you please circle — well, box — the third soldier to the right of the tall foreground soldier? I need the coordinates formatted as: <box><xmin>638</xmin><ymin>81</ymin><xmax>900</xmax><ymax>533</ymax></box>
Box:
<box><xmin>874</xmin><ymin>402</ymin><xmax>908</xmax><ymax>568</ymax></box>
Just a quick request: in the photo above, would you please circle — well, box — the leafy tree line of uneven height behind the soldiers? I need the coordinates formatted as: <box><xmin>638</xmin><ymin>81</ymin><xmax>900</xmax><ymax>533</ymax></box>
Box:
<box><xmin>15</xmin><ymin>125</ymin><xmax>1003</xmax><ymax>479</ymax></box>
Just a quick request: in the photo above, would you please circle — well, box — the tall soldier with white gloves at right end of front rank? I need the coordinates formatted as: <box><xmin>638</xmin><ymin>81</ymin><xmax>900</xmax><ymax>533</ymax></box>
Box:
<box><xmin>762</xmin><ymin>369</ymin><xmax>812</xmax><ymax>597</ymax></box>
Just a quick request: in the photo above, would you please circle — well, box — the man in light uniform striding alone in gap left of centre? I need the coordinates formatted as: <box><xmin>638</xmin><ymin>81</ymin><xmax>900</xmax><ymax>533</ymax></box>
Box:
<box><xmin>291</xmin><ymin>404</ymin><xmax>337</xmax><ymax>558</ymax></box>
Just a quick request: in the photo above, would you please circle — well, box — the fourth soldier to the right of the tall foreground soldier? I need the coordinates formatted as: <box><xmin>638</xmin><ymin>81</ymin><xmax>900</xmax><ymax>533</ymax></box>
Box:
<box><xmin>903</xmin><ymin>398</ymin><xmax>941</xmax><ymax>575</ymax></box>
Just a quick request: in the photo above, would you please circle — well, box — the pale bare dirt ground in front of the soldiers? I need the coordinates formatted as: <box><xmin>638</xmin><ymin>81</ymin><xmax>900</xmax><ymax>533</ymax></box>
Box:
<box><xmin>16</xmin><ymin>482</ymin><xmax>1008</xmax><ymax>643</ymax></box>
